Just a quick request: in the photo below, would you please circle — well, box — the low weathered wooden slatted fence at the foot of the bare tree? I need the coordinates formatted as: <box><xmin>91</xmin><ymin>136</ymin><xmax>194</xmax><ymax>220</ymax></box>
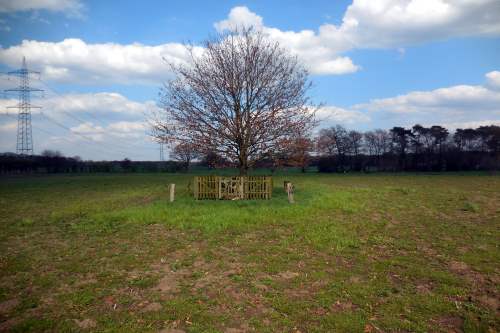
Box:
<box><xmin>193</xmin><ymin>176</ymin><xmax>273</xmax><ymax>200</ymax></box>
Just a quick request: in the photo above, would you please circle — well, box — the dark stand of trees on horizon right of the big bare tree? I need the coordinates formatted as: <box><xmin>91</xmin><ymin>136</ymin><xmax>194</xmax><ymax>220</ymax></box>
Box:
<box><xmin>310</xmin><ymin>124</ymin><xmax>500</xmax><ymax>172</ymax></box>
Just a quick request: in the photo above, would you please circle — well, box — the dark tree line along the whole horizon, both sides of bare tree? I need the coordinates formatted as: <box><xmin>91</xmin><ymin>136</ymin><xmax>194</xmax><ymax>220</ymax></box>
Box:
<box><xmin>0</xmin><ymin>125</ymin><xmax>500</xmax><ymax>174</ymax></box>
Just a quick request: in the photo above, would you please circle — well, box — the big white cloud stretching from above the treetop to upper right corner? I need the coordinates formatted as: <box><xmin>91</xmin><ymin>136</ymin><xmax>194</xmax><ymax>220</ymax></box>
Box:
<box><xmin>215</xmin><ymin>0</ymin><xmax>500</xmax><ymax>75</ymax></box>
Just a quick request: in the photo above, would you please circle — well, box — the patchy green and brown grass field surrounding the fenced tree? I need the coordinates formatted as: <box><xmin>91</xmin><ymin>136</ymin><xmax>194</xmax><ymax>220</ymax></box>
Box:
<box><xmin>0</xmin><ymin>173</ymin><xmax>500</xmax><ymax>333</ymax></box>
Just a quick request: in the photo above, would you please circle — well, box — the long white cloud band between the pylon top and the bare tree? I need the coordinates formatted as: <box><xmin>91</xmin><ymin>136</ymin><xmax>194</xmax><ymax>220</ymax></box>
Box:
<box><xmin>0</xmin><ymin>38</ymin><xmax>202</xmax><ymax>84</ymax></box>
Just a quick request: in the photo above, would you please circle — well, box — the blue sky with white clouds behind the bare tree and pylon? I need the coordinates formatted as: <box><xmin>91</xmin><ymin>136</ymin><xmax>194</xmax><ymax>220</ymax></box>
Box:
<box><xmin>0</xmin><ymin>0</ymin><xmax>500</xmax><ymax>160</ymax></box>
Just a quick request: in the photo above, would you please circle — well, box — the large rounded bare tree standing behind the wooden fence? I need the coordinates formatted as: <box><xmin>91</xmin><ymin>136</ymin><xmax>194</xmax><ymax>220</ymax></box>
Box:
<box><xmin>151</xmin><ymin>29</ymin><xmax>315</xmax><ymax>174</ymax></box>
